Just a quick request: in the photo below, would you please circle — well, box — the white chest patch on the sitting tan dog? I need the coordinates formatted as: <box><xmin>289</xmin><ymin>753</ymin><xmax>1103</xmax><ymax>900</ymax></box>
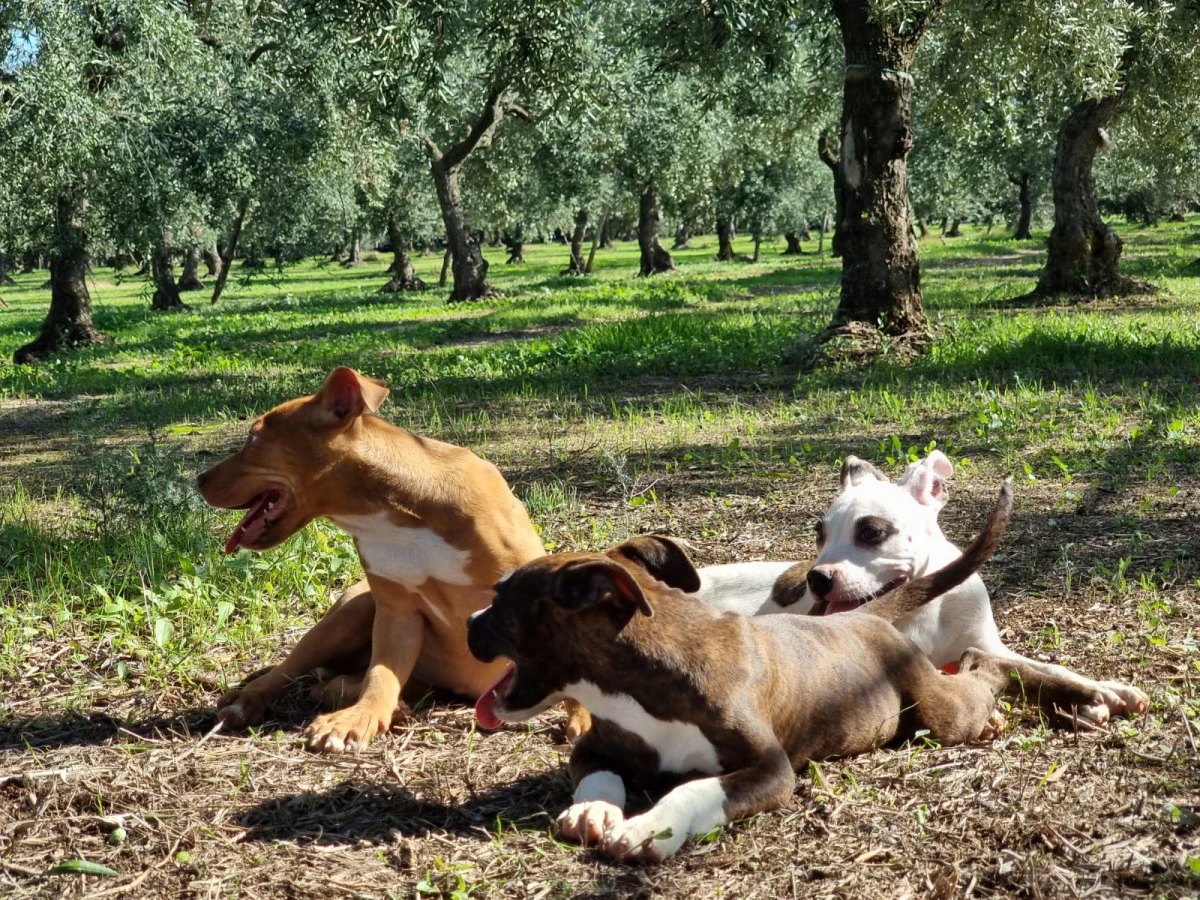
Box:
<box><xmin>334</xmin><ymin>512</ymin><xmax>472</xmax><ymax>590</ymax></box>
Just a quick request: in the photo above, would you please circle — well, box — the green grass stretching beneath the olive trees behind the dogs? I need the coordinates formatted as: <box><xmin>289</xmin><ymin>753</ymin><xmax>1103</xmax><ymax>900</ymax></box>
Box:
<box><xmin>0</xmin><ymin>222</ymin><xmax>1200</xmax><ymax>684</ymax></box>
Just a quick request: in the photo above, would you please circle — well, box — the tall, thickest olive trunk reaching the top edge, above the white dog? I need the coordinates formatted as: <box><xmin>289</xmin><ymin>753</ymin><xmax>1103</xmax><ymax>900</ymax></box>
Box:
<box><xmin>833</xmin><ymin>0</ymin><xmax>944</xmax><ymax>335</ymax></box>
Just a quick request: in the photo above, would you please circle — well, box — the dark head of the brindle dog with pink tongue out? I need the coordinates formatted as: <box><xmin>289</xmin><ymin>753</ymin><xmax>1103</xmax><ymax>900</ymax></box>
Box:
<box><xmin>467</xmin><ymin>535</ymin><xmax>700</xmax><ymax>728</ymax></box>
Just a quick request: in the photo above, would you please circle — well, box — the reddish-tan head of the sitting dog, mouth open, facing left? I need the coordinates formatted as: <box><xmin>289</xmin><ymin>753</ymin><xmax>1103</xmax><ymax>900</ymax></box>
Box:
<box><xmin>196</xmin><ymin>366</ymin><xmax>388</xmax><ymax>553</ymax></box>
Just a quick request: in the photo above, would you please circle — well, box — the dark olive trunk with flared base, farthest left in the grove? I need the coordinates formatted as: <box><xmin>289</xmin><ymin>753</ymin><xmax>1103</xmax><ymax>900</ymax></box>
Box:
<box><xmin>12</xmin><ymin>194</ymin><xmax>107</xmax><ymax>365</ymax></box>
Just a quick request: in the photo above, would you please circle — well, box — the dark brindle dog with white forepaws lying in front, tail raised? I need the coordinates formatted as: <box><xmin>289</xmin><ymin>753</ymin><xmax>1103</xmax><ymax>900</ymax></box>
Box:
<box><xmin>467</xmin><ymin>484</ymin><xmax>1096</xmax><ymax>860</ymax></box>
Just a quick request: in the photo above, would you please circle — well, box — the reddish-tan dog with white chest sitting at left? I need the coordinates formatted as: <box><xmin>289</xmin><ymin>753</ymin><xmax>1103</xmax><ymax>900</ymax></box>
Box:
<box><xmin>197</xmin><ymin>367</ymin><xmax>586</xmax><ymax>752</ymax></box>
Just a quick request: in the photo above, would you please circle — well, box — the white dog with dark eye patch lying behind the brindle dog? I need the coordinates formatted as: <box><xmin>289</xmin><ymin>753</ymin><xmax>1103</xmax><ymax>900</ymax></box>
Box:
<box><xmin>697</xmin><ymin>450</ymin><xmax>1150</xmax><ymax>727</ymax></box>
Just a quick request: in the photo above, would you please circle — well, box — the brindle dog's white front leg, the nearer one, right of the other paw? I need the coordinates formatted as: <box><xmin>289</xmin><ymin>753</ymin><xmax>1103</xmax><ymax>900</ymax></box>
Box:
<box><xmin>606</xmin><ymin>778</ymin><xmax>728</xmax><ymax>862</ymax></box>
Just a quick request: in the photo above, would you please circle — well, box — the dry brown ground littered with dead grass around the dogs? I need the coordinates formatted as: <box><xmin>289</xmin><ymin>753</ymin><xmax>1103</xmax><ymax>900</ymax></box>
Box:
<box><xmin>0</xmin><ymin>461</ymin><xmax>1200</xmax><ymax>898</ymax></box>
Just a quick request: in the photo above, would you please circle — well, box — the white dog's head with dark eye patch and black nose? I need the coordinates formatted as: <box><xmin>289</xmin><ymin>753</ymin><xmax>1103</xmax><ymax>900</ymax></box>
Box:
<box><xmin>808</xmin><ymin>450</ymin><xmax>954</xmax><ymax>613</ymax></box>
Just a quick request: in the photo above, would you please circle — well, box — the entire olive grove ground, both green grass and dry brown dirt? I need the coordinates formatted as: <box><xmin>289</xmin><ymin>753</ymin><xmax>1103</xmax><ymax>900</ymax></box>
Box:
<box><xmin>0</xmin><ymin>224</ymin><xmax>1200</xmax><ymax>898</ymax></box>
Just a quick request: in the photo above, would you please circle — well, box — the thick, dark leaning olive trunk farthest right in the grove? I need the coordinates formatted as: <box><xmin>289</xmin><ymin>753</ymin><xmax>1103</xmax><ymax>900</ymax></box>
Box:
<box><xmin>1034</xmin><ymin>91</ymin><xmax>1135</xmax><ymax>295</ymax></box>
